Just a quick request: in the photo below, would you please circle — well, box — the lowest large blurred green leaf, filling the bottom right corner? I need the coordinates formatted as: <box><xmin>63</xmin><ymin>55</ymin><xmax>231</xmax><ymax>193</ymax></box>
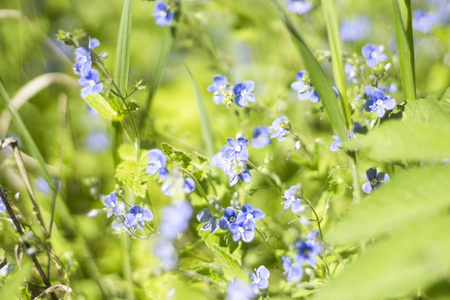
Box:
<box><xmin>313</xmin><ymin>216</ymin><xmax>450</xmax><ymax>300</ymax></box>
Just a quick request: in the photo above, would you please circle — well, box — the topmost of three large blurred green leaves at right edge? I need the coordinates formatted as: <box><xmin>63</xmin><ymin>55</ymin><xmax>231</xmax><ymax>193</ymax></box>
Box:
<box><xmin>343</xmin><ymin>121</ymin><xmax>450</xmax><ymax>162</ymax></box>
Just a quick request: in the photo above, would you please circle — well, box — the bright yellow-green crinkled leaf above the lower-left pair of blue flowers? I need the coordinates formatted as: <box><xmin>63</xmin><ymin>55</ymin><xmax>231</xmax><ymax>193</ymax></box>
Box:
<box><xmin>116</xmin><ymin>144</ymin><xmax>152</xmax><ymax>198</ymax></box>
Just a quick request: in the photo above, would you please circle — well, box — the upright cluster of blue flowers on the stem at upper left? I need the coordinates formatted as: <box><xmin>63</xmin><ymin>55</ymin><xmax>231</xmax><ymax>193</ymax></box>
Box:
<box><xmin>73</xmin><ymin>38</ymin><xmax>103</xmax><ymax>98</ymax></box>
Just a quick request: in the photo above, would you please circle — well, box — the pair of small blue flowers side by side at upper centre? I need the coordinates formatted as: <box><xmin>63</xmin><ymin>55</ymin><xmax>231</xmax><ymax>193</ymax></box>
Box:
<box><xmin>207</xmin><ymin>75</ymin><xmax>255</xmax><ymax>107</ymax></box>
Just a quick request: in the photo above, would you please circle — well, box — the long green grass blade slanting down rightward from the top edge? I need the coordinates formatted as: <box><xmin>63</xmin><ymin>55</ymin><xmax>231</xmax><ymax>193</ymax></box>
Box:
<box><xmin>268</xmin><ymin>0</ymin><xmax>347</xmax><ymax>136</ymax></box>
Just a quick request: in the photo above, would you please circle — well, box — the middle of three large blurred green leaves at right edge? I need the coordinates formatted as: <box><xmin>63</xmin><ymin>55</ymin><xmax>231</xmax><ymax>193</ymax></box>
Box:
<box><xmin>325</xmin><ymin>165</ymin><xmax>450</xmax><ymax>244</ymax></box>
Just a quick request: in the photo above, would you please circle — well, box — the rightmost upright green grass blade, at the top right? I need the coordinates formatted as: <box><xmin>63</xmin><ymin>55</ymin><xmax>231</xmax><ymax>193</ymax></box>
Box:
<box><xmin>392</xmin><ymin>0</ymin><xmax>416</xmax><ymax>100</ymax></box>
